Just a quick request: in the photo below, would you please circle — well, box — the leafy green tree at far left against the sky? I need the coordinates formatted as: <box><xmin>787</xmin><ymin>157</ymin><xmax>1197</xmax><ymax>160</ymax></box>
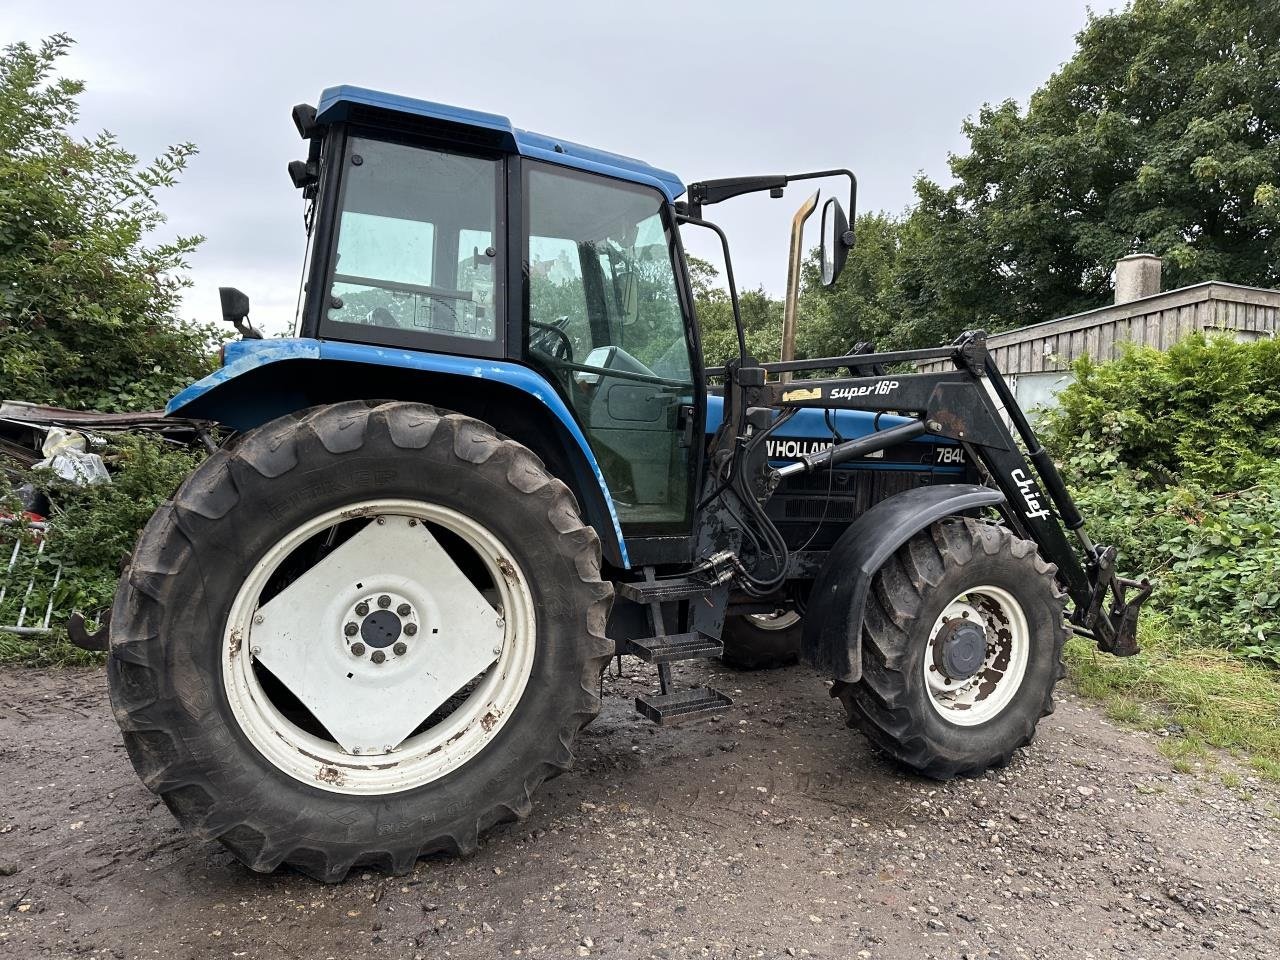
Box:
<box><xmin>0</xmin><ymin>35</ymin><xmax>220</xmax><ymax>411</ymax></box>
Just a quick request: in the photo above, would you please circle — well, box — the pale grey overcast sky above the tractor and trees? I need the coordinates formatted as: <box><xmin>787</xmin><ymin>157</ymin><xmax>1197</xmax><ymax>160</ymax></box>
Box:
<box><xmin>0</xmin><ymin>0</ymin><xmax>1111</xmax><ymax>332</ymax></box>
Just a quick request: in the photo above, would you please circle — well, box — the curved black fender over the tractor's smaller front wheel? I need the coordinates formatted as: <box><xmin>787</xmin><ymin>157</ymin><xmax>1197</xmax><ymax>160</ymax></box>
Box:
<box><xmin>800</xmin><ymin>484</ymin><xmax>1005</xmax><ymax>684</ymax></box>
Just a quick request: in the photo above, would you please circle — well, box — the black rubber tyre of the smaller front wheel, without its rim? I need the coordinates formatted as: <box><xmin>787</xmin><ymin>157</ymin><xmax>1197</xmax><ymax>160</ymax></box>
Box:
<box><xmin>832</xmin><ymin>518</ymin><xmax>1068</xmax><ymax>780</ymax></box>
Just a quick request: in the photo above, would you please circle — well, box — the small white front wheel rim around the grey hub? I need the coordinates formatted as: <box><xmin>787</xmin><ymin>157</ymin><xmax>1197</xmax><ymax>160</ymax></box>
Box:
<box><xmin>922</xmin><ymin>586</ymin><xmax>1030</xmax><ymax>727</ymax></box>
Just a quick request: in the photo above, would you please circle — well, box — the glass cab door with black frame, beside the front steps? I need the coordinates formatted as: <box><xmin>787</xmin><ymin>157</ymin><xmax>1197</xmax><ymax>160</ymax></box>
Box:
<box><xmin>522</xmin><ymin>163</ymin><xmax>699</xmax><ymax>540</ymax></box>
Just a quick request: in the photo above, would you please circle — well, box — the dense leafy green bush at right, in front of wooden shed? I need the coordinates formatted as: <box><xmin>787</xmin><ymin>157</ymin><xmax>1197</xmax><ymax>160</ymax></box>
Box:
<box><xmin>1044</xmin><ymin>335</ymin><xmax>1280</xmax><ymax>663</ymax></box>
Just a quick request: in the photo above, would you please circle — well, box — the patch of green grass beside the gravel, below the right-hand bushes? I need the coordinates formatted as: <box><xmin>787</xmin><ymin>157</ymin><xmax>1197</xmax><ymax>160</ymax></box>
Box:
<box><xmin>1065</xmin><ymin>614</ymin><xmax>1280</xmax><ymax>786</ymax></box>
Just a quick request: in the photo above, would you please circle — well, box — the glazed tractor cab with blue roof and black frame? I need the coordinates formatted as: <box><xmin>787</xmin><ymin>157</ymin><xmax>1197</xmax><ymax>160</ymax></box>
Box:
<box><xmin>293</xmin><ymin>87</ymin><xmax>704</xmax><ymax>539</ymax></box>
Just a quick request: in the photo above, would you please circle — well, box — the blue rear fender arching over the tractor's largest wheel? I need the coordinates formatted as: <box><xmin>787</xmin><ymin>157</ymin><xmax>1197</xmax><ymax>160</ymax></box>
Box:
<box><xmin>165</xmin><ymin>338</ymin><xmax>631</xmax><ymax>568</ymax></box>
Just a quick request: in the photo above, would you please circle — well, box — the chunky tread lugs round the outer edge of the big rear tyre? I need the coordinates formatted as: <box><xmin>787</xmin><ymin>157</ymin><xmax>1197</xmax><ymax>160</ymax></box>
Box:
<box><xmin>108</xmin><ymin>401</ymin><xmax>613</xmax><ymax>883</ymax></box>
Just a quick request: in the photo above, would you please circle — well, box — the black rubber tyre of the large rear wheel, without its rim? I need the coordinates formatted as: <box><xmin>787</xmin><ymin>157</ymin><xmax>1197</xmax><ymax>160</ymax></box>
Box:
<box><xmin>109</xmin><ymin>402</ymin><xmax>613</xmax><ymax>882</ymax></box>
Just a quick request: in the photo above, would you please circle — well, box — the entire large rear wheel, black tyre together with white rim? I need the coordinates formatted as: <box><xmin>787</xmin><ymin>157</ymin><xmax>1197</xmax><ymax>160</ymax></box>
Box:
<box><xmin>109</xmin><ymin>402</ymin><xmax>613</xmax><ymax>882</ymax></box>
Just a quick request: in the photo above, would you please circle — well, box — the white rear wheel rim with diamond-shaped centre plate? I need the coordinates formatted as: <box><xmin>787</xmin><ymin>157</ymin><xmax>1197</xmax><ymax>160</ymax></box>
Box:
<box><xmin>221</xmin><ymin>499</ymin><xmax>536</xmax><ymax>795</ymax></box>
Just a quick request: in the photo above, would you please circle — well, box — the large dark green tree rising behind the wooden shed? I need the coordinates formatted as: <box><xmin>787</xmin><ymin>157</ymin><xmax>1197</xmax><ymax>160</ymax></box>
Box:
<box><xmin>899</xmin><ymin>0</ymin><xmax>1280</xmax><ymax>335</ymax></box>
